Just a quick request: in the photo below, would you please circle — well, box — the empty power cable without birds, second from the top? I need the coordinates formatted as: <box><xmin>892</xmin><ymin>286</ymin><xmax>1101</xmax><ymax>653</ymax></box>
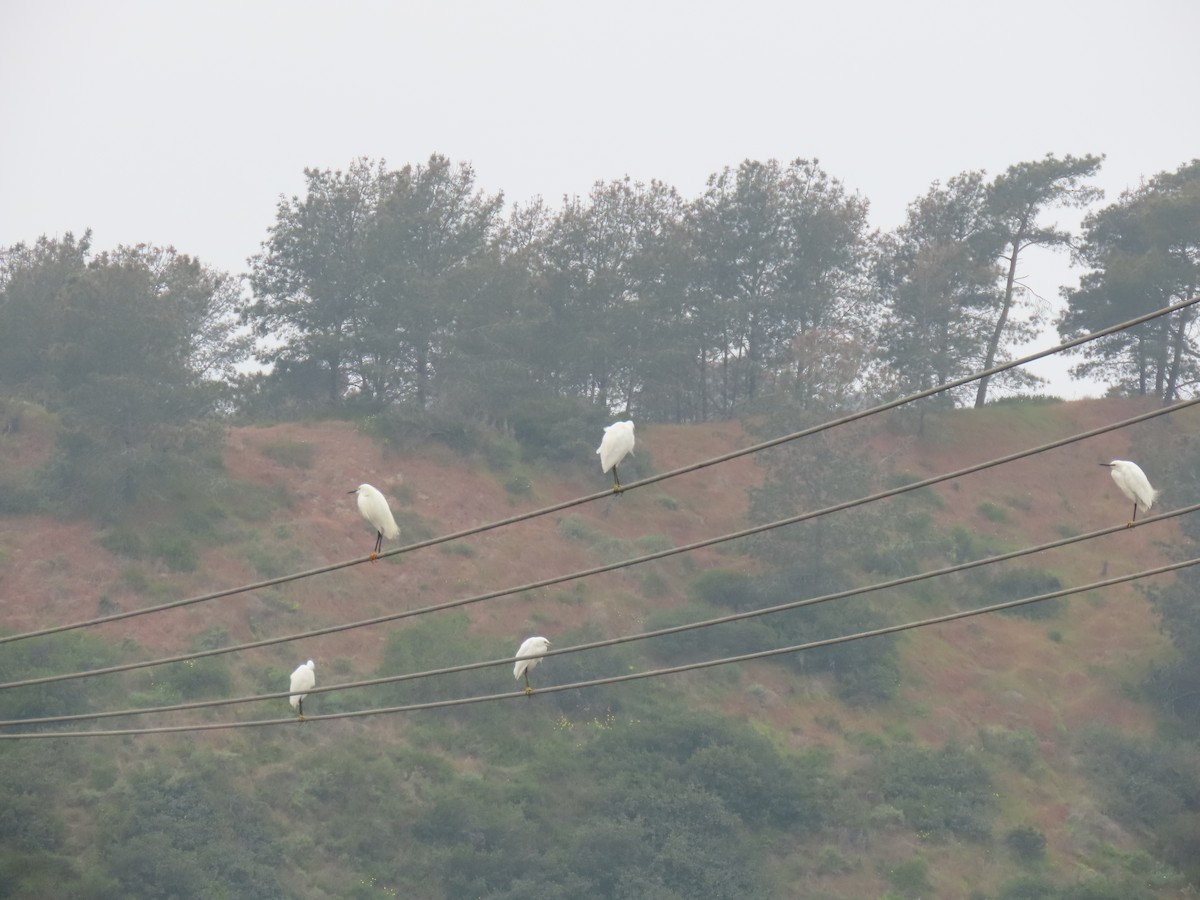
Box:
<box><xmin>0</xmin><ymin>396</ymin><xmax>1200</xmax><ymax>690</ymax></box>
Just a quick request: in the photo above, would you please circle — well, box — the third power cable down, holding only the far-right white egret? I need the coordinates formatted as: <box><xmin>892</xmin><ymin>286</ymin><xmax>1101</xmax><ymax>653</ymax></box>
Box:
<box><xmin>0</xmin><ymin>504</ymin><xmax>1200</xmax><ymax>727</ymax></box>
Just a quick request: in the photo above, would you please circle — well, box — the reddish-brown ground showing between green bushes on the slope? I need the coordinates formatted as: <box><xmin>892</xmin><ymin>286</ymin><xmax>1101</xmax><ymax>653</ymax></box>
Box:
<box><xmin>0</xmin><ymin>400</ymin><xmax>1194</xmax><ymax>883</ymax></box>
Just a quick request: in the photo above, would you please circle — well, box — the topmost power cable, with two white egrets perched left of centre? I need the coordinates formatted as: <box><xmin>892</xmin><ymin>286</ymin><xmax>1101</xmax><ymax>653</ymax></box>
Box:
<box><xmin>0</xmin><ymin>296</ymin><xmax>1200</xmax><ymax>648</ymax></box>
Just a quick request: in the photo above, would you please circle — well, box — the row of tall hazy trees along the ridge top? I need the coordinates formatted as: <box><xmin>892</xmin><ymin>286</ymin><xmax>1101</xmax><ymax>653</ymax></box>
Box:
<box><xmin>0</xmin><ymin>155</ymin><xmax>1200</xmax><ymax>446</ymax></box>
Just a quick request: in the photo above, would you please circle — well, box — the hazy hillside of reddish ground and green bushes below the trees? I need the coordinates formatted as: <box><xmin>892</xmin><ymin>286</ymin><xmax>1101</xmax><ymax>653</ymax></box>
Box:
<box><xmin>0</xmin><ymin>400</ymin><xmax>1200</xmax><ymax>900</ymax></box>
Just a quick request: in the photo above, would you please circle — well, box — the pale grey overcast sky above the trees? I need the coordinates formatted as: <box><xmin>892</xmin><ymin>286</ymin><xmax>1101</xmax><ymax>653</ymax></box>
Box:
<box><xmin>0</xmin><ymin>0</ymin><xmax>1200</xmax><ymax>396</ymax></box>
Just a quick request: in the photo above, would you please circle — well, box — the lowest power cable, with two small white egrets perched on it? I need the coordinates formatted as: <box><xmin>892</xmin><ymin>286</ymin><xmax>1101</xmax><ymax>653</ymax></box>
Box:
<box><xmin>0</xmin><ymin>558</ymin><xmax>1200</xmax><ymax>740</ymax></box>
